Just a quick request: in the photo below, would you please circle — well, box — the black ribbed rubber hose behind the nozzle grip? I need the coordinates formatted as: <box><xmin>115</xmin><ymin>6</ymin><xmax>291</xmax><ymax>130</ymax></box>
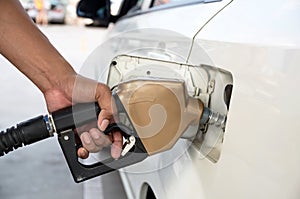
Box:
<box><xmin>0</xmin><ymin>116</ymin><xmax>51</xmax><ymax>156</ymax></box>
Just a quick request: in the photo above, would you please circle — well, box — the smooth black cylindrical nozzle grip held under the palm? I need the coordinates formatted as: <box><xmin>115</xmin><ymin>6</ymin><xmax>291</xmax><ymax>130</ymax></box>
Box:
<box><xmin>51</xmin><ymin>102</ymin><xmax>101</xmax><ymax>133</ymax></box>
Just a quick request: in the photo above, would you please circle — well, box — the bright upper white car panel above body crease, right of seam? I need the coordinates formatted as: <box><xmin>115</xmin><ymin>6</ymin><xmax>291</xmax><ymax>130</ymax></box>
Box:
<box><xmin>198</xmin><ymin>0</ymin><xmax>300</xmax><ymax>47</ymax></box>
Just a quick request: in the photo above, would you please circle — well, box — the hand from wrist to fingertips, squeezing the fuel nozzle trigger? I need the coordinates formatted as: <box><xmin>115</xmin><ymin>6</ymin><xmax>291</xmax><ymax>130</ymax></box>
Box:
<box><xmin>44</xmin><ymin>75</ymin><xmax>123</xmax><ymax>159</ymax></box>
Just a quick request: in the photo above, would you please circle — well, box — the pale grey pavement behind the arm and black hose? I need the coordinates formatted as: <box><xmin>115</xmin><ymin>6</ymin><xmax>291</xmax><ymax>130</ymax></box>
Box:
<box><xmin>0</xmin><ymin>25</ymin><xmax>126</xmax><ymax>199</ymax></box>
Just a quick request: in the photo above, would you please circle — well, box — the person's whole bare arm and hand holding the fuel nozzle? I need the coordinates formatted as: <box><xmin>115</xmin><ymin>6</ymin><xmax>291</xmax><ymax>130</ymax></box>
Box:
<box><xmin>0</xmin><ymin>0</ymin><xmax>122</xmax><ymax>159</ymax></box>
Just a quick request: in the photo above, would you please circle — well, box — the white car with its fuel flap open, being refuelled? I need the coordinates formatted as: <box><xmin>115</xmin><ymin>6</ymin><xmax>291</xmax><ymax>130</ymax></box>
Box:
<box><xmin>81</xmin><ymin>0</ymin><xmax>300</xmax><ymax>199</ymax></box>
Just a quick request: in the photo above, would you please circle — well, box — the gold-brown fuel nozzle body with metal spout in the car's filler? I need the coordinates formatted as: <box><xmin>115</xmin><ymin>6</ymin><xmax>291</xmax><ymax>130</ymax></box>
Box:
<box><xmin>115</xmin><ymin>79</ymin><xmax>226</xmax><ymax>155</ymax></box>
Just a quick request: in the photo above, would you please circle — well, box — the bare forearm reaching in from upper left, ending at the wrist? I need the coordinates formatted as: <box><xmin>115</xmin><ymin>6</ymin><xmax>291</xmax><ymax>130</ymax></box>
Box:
<box><xmin>0</xmin><ymin>0</ymin><xmax>76</xmax><ymax>92</ymax></box>
